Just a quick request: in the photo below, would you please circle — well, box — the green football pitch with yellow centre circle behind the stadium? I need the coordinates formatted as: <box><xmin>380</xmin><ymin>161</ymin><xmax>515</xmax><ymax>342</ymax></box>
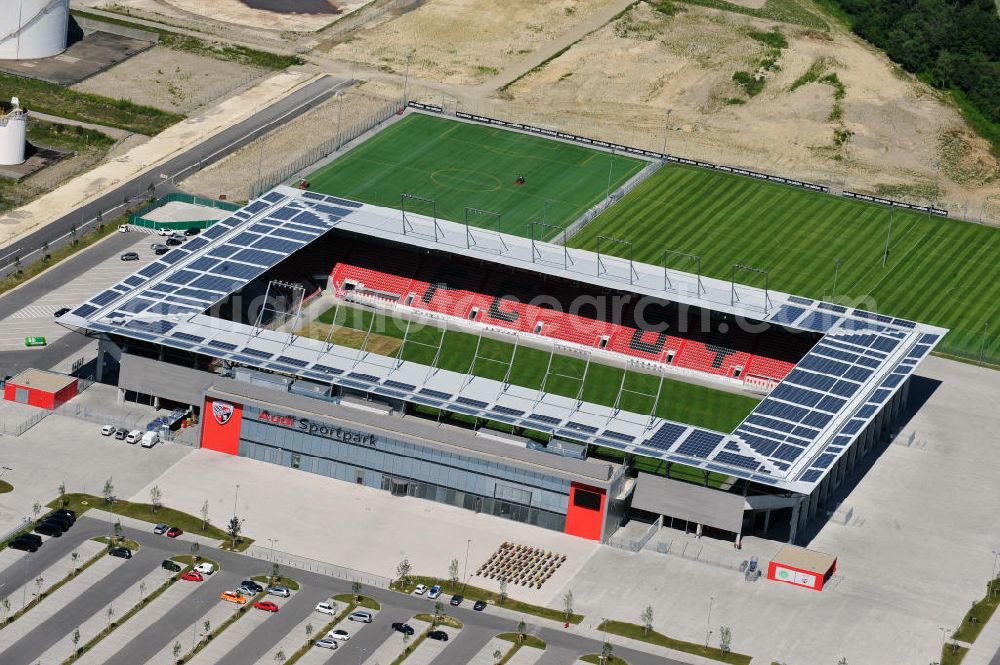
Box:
<box><xmin>307</xmin><ymin>113</ymin><xmax>647</xmax><ymax>237</ymax></box>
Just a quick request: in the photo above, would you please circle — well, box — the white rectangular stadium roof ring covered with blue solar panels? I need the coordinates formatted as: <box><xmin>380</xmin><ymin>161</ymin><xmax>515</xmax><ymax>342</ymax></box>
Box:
<box><xmin>59</xmin><ymin>186</ymin><xmax>947</xmax><ymax>494</ymax></box>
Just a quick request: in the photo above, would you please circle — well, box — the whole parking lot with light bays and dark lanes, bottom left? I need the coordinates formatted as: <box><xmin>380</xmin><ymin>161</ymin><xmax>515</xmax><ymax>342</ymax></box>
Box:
<box><xmin>0</xmin><ymin>516</ymin><xmax>664</xmax><ymax>665</ymax></box>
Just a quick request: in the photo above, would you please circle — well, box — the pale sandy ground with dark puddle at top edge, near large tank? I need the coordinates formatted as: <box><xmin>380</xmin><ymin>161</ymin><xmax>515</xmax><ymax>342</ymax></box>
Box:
<box><xmin>89</xmin><ymin>0</ymin><xmax>371</xmax><ymax>32</ymax></box>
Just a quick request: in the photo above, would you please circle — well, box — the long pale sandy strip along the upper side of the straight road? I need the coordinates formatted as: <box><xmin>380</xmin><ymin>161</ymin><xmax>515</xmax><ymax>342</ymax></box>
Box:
<box><xmin>0</xmin><ymin>71</ymin><xmax>315</xmax><ymax>248</ymax></box>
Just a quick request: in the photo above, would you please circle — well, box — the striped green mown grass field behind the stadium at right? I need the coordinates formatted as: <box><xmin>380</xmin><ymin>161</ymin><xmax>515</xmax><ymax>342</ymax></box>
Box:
<box><xmin>569</xmin><ymin>165</ymin><xmax>1000</xmax><ymax>364</ymax></box>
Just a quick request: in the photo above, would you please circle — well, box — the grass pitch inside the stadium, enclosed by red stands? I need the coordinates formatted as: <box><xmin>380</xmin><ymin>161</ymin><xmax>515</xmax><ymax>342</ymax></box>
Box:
<box><xmin>314</xmin><ymin>307</ymin><xmax>758</xmax><ymax>432</ymax></box>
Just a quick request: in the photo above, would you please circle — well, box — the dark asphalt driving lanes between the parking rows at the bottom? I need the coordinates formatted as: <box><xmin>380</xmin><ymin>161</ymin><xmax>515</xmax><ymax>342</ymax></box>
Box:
<box><xmin>4</xmin><ymin>516</ymin><xmax>682</xmax><ymax>665</ymax></box>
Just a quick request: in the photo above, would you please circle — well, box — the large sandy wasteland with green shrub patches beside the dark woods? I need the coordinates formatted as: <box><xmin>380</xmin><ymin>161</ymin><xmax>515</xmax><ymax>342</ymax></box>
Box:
<box><xmin>472</xmin><ymin>3</ymin><xmax>1000</xmax><ymax>219</ymax></box>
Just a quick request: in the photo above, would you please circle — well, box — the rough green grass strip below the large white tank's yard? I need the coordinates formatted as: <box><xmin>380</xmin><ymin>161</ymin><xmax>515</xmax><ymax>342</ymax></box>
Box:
<box><xmin>0</xmin><ymin>72</ymin><xmax>184</xmax><ymax>136</ymax></box>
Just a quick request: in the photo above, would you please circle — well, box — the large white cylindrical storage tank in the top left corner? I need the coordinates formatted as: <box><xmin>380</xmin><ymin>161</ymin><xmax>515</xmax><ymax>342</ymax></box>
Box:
<box><xmin>0</xmin><ymin>0</ymin><xmax>69</xmax><ymax>60</ymax></box>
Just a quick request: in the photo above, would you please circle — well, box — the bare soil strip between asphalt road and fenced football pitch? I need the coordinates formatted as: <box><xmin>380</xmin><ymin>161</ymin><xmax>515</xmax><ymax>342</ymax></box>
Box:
<box><xmin>180</xmin><ymin>84</ymin><xmax>399</xmax><ymax>201</ymax></box>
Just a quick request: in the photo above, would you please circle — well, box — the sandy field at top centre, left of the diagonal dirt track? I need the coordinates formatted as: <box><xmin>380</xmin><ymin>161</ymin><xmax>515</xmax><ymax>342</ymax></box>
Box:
<box><xmin>329</xmin><ymin>0</ymin><xmax>608</xmax><ymax>85</ymax></box>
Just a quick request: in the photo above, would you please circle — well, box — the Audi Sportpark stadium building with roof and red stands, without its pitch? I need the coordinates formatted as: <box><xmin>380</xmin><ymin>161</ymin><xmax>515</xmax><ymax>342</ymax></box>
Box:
<box><xmin>59</xmin><ymin>187</ymin><xmax>947</xmax><ymax>540</ymax></box>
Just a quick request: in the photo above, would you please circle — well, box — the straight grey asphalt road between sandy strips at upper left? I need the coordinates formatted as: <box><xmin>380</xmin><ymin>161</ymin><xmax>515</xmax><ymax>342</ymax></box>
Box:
<box><xmin>0</xmin><ymin>76</ymin><xmax>350</xmax><ymax>273</ymax></box>
